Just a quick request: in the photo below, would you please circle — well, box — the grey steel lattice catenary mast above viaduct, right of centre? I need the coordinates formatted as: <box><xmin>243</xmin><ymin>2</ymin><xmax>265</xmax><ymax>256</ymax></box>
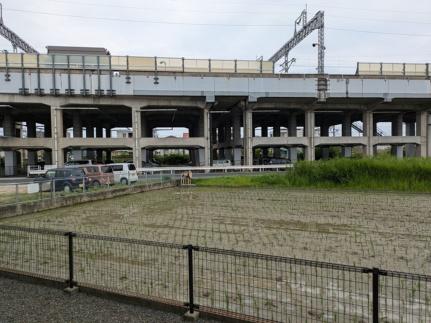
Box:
<box><xmin>269</xmin><ymin>9</ymin><xmax>326</xmax><ymax>75</ymax></box>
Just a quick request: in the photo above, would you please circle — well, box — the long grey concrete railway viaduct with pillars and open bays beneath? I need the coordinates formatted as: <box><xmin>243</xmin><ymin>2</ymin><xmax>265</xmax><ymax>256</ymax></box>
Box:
<box><xmin>0</xmin><ymin>54</ymin><xmax>431</xmax><ymax>175</ymax></box>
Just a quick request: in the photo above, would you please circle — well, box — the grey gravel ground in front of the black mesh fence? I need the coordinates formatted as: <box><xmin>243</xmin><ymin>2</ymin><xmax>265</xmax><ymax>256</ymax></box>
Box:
<box><xmin>0</xmin><ymin>277</ymin><xmax>217</xmax><ymax>323</ymax></box>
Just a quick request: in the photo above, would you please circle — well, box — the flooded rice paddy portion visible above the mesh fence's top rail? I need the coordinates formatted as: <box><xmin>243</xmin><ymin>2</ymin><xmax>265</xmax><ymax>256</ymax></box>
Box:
<box><xmin>1</xmin><ymin>188</ymin><xmax>431</xmax><ymax>274</ymax></box>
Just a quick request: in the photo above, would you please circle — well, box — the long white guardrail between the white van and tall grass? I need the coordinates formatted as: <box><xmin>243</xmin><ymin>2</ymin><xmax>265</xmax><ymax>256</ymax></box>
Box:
<box><xmin>138</xmin><ymin>164</ymin><xmax>293</xmax><ymax>174</ymax></box>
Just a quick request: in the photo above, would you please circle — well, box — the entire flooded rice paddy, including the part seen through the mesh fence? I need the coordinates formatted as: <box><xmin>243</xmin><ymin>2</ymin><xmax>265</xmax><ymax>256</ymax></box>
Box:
<box><xmin>0</xmin><ymin>188</ymin><xmax>431</xmax><ymax>323</ymax></box>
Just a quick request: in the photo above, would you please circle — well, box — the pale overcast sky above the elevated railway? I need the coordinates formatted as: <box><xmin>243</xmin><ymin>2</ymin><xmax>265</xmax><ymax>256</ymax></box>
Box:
<box><xmin>0</xmin><ymin>0</ymin><xmax>431</xmax><ymax>73</ymax></box>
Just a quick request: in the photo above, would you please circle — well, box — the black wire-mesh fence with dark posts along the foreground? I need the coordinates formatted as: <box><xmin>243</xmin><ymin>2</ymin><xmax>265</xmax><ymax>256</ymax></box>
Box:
<box><xmin>0</xmin><ymin>225</ymin><xmax>431</xmax><ymax>323</ymax></box>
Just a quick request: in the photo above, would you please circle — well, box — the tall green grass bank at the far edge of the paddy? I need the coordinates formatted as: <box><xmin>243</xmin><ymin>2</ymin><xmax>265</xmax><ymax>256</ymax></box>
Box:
<box><xmin>195</xmin><ymin>158</ymin><xmax>431</xmax><ymax>192</ymax></box>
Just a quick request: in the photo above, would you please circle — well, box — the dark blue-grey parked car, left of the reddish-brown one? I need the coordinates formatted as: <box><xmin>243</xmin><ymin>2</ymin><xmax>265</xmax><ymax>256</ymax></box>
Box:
<box><xmin>34</xmin><ymin>168</ymin><xmax>90</xmax><ymax>193</ymax></box>
